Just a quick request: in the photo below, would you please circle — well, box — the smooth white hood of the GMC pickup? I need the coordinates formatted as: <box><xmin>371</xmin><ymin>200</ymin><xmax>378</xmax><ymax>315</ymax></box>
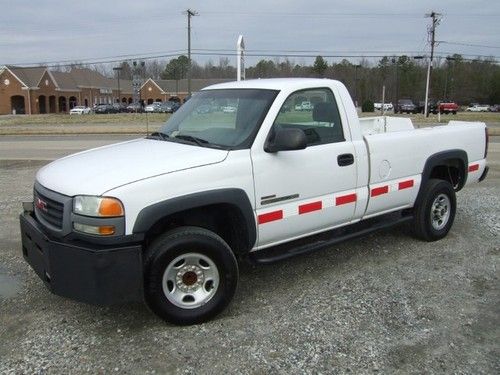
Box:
<box><xmin>36</xmin><ymin>139</ymin><xmax>228</xmax><ymax>196</ymax></box>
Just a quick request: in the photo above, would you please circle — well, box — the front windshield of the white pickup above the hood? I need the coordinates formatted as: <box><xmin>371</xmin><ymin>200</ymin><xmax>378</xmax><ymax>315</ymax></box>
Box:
<box><xmin>159</xmin><ymin>89</ymin><xmax>278</xmax><ymax>149</ymax></box>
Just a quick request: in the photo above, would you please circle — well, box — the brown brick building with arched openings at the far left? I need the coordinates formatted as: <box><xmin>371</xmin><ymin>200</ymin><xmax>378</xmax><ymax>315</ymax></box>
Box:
<box><xmin>0</xmin><ymin>66</ymin><xmax>132</xmax><ymax>115</ymax></box>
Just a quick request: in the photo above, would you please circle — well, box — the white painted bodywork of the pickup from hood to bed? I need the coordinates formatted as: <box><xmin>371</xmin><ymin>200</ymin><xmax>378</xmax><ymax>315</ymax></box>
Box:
<box><xmin>33</xmin><ymin>79</ymin><xmax>486</xmax><ymax>250</ymax></box>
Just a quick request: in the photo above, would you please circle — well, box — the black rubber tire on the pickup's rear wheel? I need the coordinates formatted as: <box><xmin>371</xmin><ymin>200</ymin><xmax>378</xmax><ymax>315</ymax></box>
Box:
<box><xmin>413</xmin><ymin>179</ymin><xmax>457</xmax><ymax>242</ymax></box>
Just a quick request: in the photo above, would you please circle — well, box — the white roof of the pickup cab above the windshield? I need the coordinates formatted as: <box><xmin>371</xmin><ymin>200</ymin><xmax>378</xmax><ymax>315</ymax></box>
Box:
<box><xmin>203</xmin><ymin>78</ymin><xmax>340</xmax><ymax>90</ymax></box>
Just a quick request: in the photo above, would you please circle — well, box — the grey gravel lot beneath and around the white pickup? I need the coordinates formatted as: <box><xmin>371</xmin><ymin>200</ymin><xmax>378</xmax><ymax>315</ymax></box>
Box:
<box><xmin>0</xmin><ymin>156</ymin><xmax>500</xmax><ymax>374</ymax></box>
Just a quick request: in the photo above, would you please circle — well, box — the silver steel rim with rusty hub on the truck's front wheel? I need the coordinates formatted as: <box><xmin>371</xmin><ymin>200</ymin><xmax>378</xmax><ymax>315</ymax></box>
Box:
<box><xmin>162</xmin><ymin>253</ymin><xmax>219</xmax><ymax>309</ymax></box>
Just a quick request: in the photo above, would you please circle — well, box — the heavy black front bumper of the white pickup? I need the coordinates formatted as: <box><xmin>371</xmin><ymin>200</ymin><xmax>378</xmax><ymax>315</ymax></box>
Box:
<box><xmin>20</xmin><ymin>212</ymin><xmax>144</xmax><ymax>305</ymax></box>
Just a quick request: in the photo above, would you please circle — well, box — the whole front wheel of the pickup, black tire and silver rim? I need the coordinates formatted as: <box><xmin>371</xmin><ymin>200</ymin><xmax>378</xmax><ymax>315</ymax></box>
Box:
<box><xmin>144</xmin><ymin>227</ymin><xmax>238</xmax><ymax>325</ymax></box>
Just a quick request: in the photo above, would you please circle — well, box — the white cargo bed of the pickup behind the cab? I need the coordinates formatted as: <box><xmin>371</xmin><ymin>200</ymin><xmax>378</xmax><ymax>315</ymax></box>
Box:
<box><xmin>360</xmin><ymin>117</ymin><xmax>486</xmax><ymax>218</ymax></box>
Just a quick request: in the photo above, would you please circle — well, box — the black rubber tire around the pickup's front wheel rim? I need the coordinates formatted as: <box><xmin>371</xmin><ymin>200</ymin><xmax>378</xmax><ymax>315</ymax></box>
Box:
<box><xmin>144</xmin><ymin>227</ymin><xmax>238</xmax><ymax>325</ymax></box>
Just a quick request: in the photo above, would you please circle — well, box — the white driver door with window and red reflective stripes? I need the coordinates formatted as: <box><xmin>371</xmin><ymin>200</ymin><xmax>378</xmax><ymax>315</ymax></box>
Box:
<box><xmin>251</xmin><ymin>88</ymin><xmax>357</xmax><ymax>248</ymax></box>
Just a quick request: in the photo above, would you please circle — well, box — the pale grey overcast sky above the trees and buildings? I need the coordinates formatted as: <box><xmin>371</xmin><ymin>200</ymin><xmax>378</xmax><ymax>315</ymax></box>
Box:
<box><xmin>0</xmin><ymin>0</ymin><xmax>500</xmax><ymax>66</ymax></box>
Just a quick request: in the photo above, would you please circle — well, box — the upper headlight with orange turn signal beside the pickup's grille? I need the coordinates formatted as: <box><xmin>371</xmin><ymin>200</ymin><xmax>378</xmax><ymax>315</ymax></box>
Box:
<box><xmin>73</xmin><ymin>195</ymin><xmax>125</xmax><ymax>217</ymax></box>
